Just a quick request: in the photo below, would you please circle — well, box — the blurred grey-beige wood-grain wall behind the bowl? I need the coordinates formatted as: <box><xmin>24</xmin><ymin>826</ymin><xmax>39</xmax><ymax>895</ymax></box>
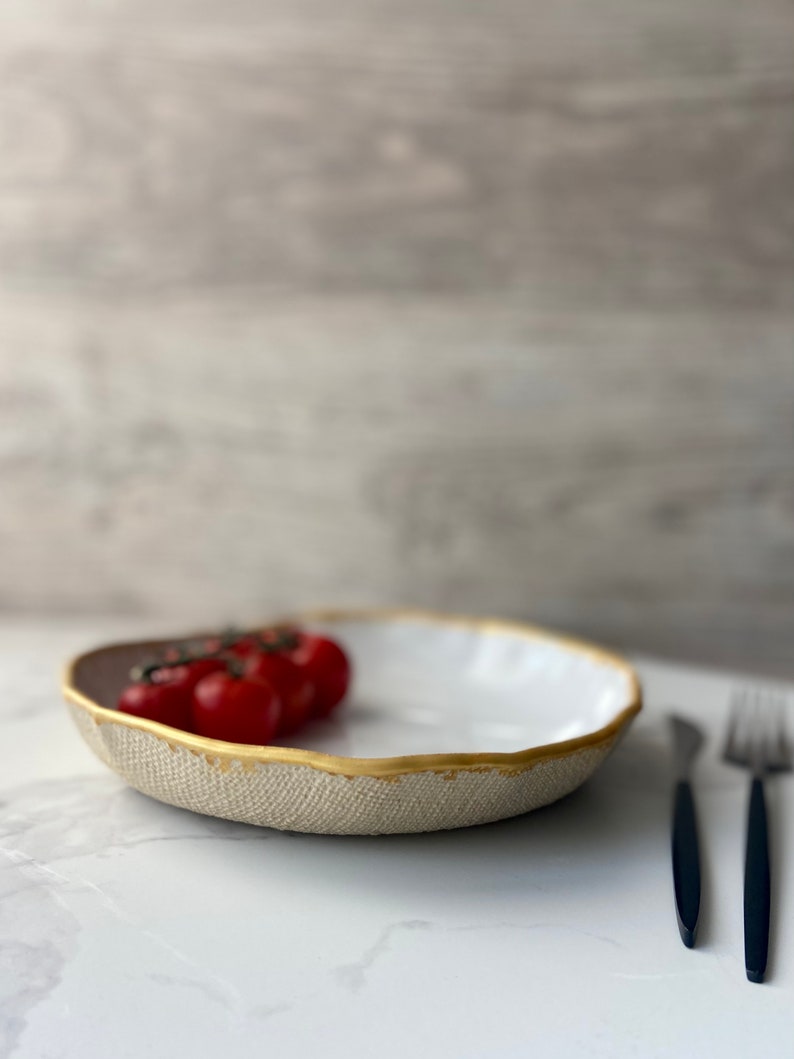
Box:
<box><xmin>0</xmin><ymin>0</ymin><xmax>794</xmax><ymax>666</ymax></box>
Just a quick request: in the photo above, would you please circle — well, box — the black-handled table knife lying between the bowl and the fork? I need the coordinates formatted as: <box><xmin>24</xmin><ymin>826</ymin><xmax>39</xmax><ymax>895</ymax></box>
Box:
<box><xmin>669</xmin><ymin>716</ymin><xmax>704</xmax><ymax>949</ymax></box>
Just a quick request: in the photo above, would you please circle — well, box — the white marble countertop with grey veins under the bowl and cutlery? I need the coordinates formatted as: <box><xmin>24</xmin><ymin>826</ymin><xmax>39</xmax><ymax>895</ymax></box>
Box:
<box><xmin>0</xmin><ymin>623</ymin><xmax>794</xmax><ymax>1059</ymax></box>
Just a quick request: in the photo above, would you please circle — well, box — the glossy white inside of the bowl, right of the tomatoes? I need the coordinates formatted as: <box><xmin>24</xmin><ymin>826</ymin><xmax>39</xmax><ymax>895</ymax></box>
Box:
<box><xmin>283</xmin><ymin>618</ymin><xmax>635</xmax><ymax>758</ymax></box>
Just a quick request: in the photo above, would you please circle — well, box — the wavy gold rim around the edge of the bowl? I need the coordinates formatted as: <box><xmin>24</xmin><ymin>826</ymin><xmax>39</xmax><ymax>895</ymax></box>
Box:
<box><xmin>61</xmin><ymin>608</ymin><xmax>642</xmax><ymax>778</ymax></box>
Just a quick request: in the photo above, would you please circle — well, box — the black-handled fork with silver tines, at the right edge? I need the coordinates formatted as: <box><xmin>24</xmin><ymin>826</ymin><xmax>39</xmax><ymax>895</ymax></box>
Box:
<box><xmin>722</xmin><ymin>690</ymin><xmax>792</xmax><ymax>982</ymax></box>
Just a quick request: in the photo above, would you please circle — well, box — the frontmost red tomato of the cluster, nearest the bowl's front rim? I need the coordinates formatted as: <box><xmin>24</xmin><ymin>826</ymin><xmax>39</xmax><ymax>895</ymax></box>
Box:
<box><xmin>192</xmin><ymin>670</ymin><xmax>282</xmax><ymax>746</ymax></box>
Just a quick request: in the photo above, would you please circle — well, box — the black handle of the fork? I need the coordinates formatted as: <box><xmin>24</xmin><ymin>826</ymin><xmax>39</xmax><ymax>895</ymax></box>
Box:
<box><xmin>744</xmin><ymin>776</ymin><xmax>771</xmax><ymax>982</ymax></box>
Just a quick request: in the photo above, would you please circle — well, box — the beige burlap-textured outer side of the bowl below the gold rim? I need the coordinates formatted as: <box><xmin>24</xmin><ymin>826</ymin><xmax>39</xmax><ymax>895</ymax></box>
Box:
<box><xmin>69</xmin><ymin>703</ymin><xmax>614</xmax><ymax>834</ymax></box>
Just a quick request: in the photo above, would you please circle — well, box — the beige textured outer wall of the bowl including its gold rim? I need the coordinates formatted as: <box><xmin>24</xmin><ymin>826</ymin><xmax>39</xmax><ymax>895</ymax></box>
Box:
<box><xmin>64</xmin><ymin>614</ymin><xmax>640</xmax><ymax>834</ymax></box>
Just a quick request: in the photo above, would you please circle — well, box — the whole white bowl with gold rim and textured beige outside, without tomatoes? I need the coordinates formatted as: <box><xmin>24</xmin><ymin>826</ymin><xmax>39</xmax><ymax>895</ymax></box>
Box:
<box><xmin>64</xmin><ymin>611</ymin><xmax>640</xmax><ymax>834</ymax></box>
